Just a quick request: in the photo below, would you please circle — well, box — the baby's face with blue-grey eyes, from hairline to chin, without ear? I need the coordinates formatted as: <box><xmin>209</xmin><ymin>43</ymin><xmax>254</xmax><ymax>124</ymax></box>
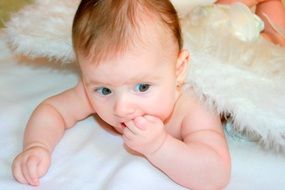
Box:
<box><xmin>80</xmin><ymin>43</ymin><xmax>177</xmax><ymax>132</ymax></box>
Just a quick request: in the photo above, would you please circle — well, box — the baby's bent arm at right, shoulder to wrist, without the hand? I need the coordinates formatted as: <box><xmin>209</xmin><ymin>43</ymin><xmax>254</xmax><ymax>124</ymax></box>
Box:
<box><xmin>145</xmin><ymin>104</ymin><xmax>231</xmax><ymax>189</ymax></box>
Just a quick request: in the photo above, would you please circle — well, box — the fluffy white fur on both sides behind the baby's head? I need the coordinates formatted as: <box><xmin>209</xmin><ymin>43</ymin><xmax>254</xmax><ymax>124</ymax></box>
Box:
<box><xmin>3</xmin><ymin>0</ymin><xmax>285</xmax><ymax>150</ymax></box>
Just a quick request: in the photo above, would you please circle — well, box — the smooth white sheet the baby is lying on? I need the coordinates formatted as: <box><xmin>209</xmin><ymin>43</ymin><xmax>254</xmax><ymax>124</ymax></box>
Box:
<box><xmin>0</xmin><ymin>33</ymin><xmax>285</xmax><ymax>190</ymax></box>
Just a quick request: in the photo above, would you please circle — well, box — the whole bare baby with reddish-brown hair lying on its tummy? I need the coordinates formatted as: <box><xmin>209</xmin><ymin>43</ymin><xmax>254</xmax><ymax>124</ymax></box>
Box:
<box><xmin>13</xmin><ymin>0</ymin><xmax>231</xmax><ymax>189</ymax></box>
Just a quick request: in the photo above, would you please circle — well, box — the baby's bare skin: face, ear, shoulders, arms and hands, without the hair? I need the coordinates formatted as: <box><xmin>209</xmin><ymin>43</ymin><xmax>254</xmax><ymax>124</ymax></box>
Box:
<box><xmin>13</xmin><ymin>12</ymin><xmax>231</xmax><ymax>189</ymax></box>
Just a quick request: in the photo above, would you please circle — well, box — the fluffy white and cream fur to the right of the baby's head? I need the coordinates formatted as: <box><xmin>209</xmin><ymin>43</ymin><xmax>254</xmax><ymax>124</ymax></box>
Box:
<box><xmin>182</xmin><ymin>4</ymin><xmax>285</xmax><ymax>151</ymax></box>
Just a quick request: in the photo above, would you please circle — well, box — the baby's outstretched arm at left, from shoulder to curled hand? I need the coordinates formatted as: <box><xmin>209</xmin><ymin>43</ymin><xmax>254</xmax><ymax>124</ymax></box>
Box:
<box><xmin>13</xmin><ymin>82</ymin><xmax>93</xmax><ymax>185</ymax></box>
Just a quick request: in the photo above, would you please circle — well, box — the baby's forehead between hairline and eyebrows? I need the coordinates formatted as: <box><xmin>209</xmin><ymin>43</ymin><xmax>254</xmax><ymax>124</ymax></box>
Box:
<box><xmin>80</xmin><ymin>37</ymin><xmax>177</xmax><ymax>75</ymax></box>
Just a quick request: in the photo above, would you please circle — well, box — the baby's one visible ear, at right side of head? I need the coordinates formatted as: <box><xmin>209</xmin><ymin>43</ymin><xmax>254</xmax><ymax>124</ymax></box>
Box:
<box><xmin>176</xmin><ymin>49</ymin><xmax>190</xmax><ymax>83</ymax></box>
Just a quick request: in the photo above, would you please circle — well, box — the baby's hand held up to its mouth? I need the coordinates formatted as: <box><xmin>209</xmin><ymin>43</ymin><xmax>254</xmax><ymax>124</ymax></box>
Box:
<box><xmin>123</xmin><ymin>115</ymin><xmax>167</xmax><ymax>155</ymax></box>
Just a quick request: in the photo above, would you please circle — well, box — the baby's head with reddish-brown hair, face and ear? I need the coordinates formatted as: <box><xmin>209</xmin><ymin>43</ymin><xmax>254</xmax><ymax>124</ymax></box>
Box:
<box><xmin>72</xmin><ymin>0</ymin><xmax>189</xmax><ymax>130</ymax></box>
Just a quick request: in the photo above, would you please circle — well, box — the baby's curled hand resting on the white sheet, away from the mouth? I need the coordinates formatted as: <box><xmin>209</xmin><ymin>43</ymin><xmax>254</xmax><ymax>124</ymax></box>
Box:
<box><xmin>12</xmin><ymin>146</ymin><xmax>51</xmax><ymax>186</ymax></box>
